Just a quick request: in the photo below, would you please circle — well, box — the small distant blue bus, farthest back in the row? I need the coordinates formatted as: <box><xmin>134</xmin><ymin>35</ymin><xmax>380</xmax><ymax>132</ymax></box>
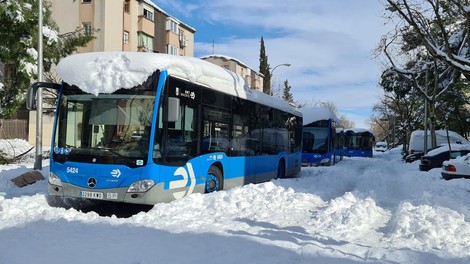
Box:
<box><xmin>342</xmin><ymin>128</ymin><xmax>375</xmax><ymax>158</ymax></box>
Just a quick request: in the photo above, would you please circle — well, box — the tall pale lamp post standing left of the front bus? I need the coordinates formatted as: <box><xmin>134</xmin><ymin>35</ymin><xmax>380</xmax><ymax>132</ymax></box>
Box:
<box><xmin>34</xmin><ymin>0</ymin><xmax>43</xmax><ymax>170</ymax></box>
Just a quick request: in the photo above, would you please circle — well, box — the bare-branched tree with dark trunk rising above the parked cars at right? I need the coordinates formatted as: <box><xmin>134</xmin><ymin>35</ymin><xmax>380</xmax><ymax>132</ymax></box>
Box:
<box><xmin>378</xmin><ymin>0</ymin><xmax>470</xmax><ymax>151</ymax></box>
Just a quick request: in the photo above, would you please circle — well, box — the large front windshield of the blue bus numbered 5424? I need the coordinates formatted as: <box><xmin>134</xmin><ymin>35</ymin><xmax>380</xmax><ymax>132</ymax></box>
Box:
<box><xmin>53</xmin><ymin>84</ymin><xmax>155</xmax><ymax>166</ymax></box>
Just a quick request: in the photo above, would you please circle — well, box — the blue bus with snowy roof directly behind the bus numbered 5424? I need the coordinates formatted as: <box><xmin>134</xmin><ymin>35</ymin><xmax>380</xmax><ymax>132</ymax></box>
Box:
<box><xmin>299</xmin><ymin>107</ymin><xmax>342</xmax><ymax>166</ymax></box>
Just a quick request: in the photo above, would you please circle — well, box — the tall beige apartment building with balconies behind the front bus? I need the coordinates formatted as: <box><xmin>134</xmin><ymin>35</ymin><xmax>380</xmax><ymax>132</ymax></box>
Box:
<box><xmin>29</xmin><ymin>0</ymin><xmax>196</xmax><ymax>146</ymax></box>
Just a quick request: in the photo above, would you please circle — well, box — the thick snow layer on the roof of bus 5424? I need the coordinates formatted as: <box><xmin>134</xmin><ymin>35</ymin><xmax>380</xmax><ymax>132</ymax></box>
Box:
<box><xmin>57</xmin><ymin>52</ymin><xmax>301</xmax><ymax>115</ymax></box>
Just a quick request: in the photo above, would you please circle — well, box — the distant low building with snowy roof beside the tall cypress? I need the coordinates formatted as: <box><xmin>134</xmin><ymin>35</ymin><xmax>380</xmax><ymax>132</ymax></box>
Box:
<box><xmin>201</xmin><ymin>54</ymin><xmax>263</xmax><ymax>91</ymax></box>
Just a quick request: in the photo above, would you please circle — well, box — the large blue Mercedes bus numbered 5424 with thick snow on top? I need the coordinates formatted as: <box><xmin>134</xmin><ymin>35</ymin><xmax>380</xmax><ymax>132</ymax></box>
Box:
<box><xmin>27</xmin><ymin>52</ymin><xmax>302</xmax><ymax>205</ymax></box>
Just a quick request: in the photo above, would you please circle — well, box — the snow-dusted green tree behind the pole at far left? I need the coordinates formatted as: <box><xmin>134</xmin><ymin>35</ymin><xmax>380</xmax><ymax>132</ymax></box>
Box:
<box><xmin>0</xmin><ymin>0</ymin><xmax>94</xmax><ymax>117</ymax></box>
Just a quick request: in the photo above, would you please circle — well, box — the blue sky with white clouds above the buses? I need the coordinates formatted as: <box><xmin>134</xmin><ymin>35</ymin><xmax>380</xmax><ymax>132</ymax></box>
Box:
<box><xmin>152</xmin><ymin>0</ymin><xmax>389</xmax><ymax>128</ymax></box>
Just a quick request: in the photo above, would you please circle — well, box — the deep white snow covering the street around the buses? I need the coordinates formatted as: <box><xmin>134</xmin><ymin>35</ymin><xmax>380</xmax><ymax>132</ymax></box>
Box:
<box><xmin>0</xmin><ymin>139</ymin><xmax>470</xmax><ymax>264</ymax></box>
